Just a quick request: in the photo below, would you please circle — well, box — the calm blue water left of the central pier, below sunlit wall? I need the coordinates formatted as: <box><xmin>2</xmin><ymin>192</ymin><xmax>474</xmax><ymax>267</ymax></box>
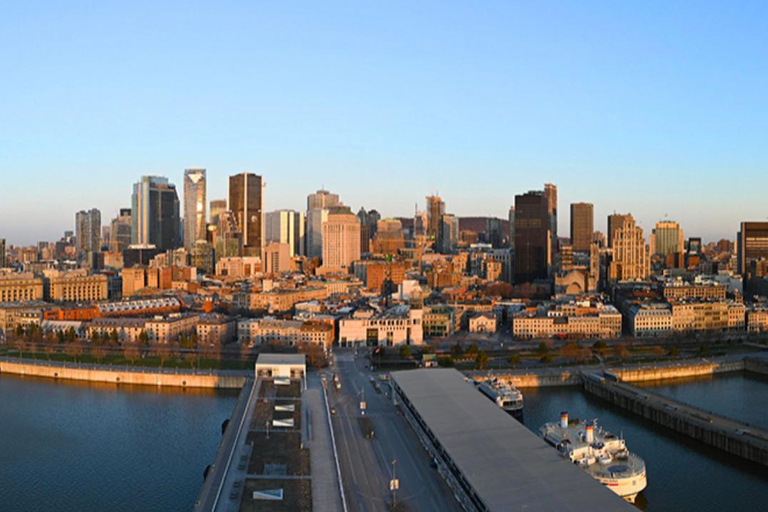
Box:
<box><xmin>0</xmin><ymin>376</ymin><xmax>237</xmax><ymax>512</ymax></box>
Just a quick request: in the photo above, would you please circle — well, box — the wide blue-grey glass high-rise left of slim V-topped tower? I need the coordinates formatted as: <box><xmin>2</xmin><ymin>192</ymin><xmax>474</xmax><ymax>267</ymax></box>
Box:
<box><xmin>131</xmin><ymin>176</ymin><xmax>181</xmax><ymax>251</ymax></box>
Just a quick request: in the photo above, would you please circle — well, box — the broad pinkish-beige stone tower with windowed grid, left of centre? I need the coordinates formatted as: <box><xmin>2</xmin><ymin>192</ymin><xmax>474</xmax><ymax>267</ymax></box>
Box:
<box><xmin>323</xmin><ymin>206</ymin><xmax>360</xmax><ymax>270</ymax></box>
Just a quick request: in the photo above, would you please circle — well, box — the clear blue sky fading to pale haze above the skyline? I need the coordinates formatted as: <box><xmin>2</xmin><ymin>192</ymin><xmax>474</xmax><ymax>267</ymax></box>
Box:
<box><xmin>0</xmin><ymin>0</ymin><xmax>768</xmax><ymax>244</ymax></box>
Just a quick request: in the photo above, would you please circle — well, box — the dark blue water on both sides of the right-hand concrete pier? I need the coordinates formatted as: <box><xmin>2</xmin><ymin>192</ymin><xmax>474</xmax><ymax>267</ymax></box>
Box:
<box><xmin>523</xmin><ymin>374</ymin><xmax>768</xmax><ymax>511</ymax></box>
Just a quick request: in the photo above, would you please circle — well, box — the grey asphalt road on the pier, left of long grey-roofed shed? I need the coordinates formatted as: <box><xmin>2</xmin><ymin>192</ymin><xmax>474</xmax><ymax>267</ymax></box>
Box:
<box><xmin>329</xmin><ymin>350</ymin><xmax>461</xmax><ymax>512</ymax></box>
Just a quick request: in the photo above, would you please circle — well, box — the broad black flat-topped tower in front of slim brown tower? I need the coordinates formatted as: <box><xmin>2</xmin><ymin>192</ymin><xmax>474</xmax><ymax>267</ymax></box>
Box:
<box><xmin>515</xmin><ymin>190</ymin><xmax>552</xmax><ymax>283</ymax></box>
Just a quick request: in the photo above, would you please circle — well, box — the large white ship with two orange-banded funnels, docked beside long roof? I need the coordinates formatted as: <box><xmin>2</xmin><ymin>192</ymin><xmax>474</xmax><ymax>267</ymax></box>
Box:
<box><xmin>539</xmin><ymin>412</ymin><xmax>648</xmax><ymax>503</ymax></box>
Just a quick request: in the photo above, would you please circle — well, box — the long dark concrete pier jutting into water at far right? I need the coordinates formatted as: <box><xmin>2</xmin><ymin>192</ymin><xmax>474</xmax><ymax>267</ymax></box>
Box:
<box><xmin>583</xmin><ymin>374</ymin><xmax>768</xmax><ymax>466</ymax></box>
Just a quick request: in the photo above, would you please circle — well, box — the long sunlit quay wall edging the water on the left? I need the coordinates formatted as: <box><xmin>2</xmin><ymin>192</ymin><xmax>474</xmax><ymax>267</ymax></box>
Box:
<box><xmin>0</xmin><ymin>359</ymin><xmax>248</xmax><ymax>389</ymax></box>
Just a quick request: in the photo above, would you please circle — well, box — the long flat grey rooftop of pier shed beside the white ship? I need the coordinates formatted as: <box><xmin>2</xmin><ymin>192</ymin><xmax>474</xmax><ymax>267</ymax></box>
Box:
<box><xmin>392</xmin><ymin>369</ymin><xmax>632</xmax><ymax>512</ymax></box>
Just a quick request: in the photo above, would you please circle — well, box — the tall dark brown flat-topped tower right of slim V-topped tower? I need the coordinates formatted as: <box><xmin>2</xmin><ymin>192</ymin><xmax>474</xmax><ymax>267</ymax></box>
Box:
<box><xmin>229</xmin><ymin>172</ymin><xmax>264</xmax><ymax>256</ymax></box>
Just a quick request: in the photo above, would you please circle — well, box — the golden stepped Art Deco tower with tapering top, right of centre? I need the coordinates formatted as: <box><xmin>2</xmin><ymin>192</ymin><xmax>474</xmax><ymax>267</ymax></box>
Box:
<box><xmin>608</xmin><ymin>214</ymin><xmax>651</xmax><ymax>281</ymax></box>
